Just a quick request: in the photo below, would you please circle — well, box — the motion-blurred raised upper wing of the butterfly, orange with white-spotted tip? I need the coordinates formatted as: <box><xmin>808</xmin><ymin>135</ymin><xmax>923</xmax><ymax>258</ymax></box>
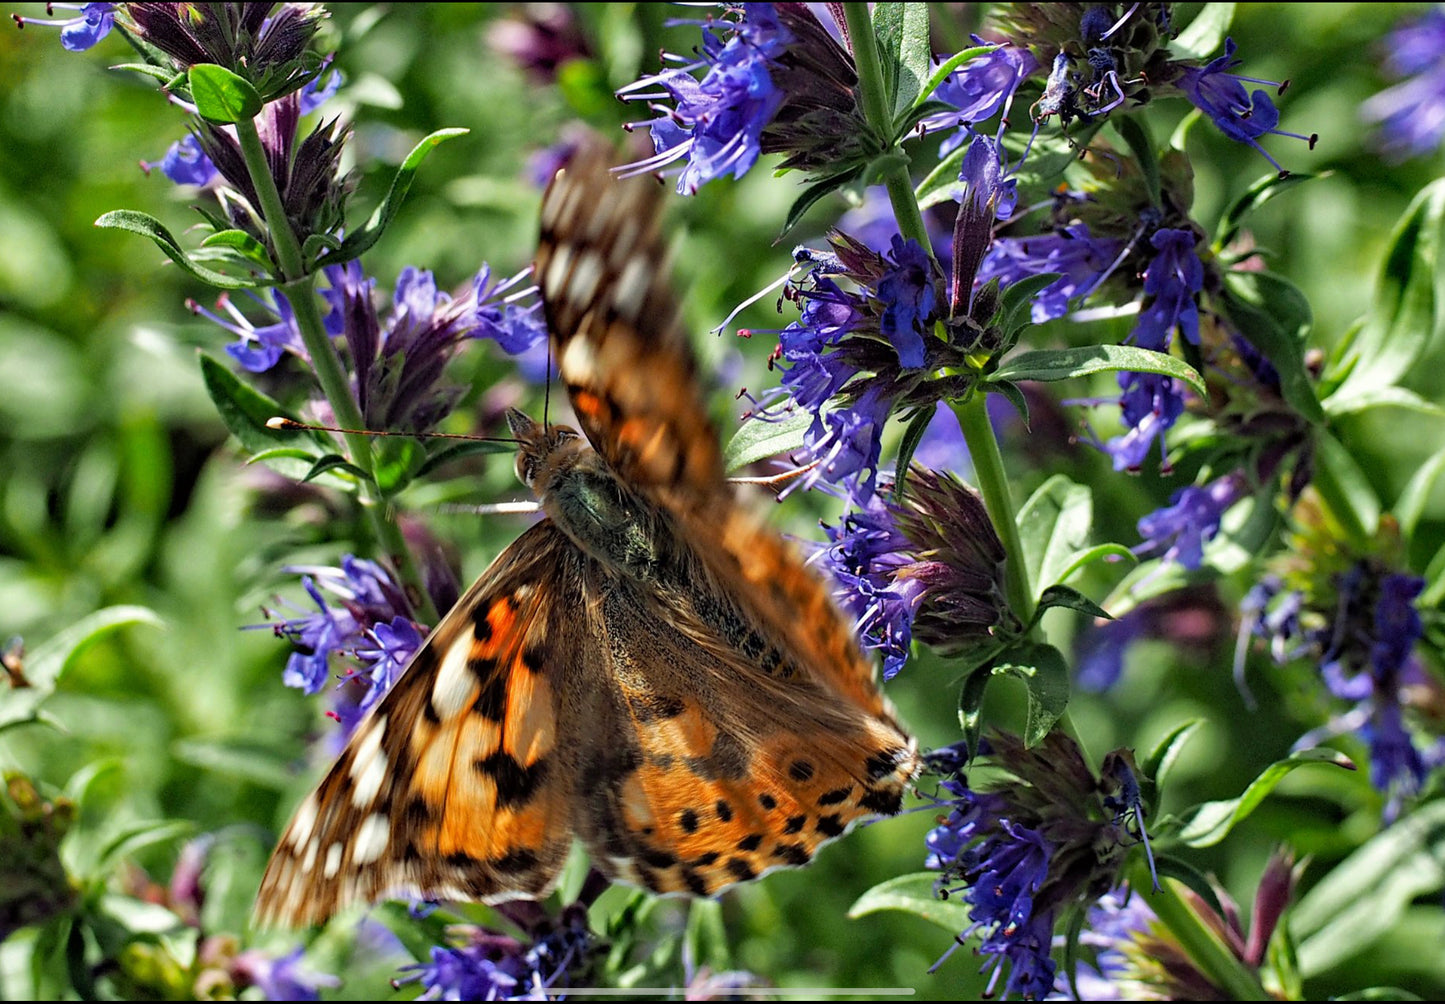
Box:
<box><xmin>533</xmin><ymin>143</ymin><xmax>724</xmax><ymax>507</ymax></box>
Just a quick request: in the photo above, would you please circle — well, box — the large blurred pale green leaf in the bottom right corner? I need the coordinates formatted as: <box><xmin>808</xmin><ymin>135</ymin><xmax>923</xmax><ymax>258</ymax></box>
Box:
<box><xmin>1289</xmin><ymin>799</ymin><xmax>1445</xmax><ymax>978</ymax></box>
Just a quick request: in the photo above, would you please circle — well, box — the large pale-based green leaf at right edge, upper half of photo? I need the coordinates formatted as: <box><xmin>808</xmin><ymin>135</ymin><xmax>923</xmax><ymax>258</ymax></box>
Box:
<box><xmin>1331</xmin><ymin>179</ymin><xmax>1445</xmax><ymax>399</ymax></box>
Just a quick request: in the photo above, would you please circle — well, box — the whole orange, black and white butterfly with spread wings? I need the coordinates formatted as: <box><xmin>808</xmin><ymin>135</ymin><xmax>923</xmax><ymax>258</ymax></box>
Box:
<box><xmin>256</xmin><ymin>143</ymin><xmax>919</xmax><ymax>926</ymax></box>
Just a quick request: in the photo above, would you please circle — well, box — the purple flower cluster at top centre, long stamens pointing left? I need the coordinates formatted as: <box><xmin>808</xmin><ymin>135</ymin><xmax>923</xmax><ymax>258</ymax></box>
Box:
<box><xmin>618</xmin><ymin>3</ymin><xmax>792</xmax><ymax>195</ymax></box>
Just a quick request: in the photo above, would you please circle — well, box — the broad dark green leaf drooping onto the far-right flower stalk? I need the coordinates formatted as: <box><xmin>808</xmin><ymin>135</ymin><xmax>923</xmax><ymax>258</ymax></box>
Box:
<box><xmin>1222</xmin><ymin>272</ymin><xmax>1325</xmax><ymax>425</ymax></box>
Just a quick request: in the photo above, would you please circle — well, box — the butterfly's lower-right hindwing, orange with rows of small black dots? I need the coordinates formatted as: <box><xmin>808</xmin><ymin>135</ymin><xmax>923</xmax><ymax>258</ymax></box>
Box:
<box><xmin>578</xmin><ymin>572</ymin><xmax>915</xmax><ymax>896</ymax></box>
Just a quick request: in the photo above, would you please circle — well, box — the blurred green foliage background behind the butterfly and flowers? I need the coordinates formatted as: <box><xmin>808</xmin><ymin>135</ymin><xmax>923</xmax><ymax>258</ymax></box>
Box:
<box><xmin>0</xmin><ymin>4</ymin><xmax>1445</xmax><ymax>998</ymax></box>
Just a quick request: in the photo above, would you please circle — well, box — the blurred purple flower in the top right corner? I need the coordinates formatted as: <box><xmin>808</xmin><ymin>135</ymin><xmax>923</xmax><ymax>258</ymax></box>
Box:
<box><xmin>1360</xmin><ymin>7</ymin><xmax>1445</xmax><ymax>163</ymax></box>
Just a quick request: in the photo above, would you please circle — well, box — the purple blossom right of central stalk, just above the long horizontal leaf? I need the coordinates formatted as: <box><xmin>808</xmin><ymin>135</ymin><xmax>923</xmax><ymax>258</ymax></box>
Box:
<box><xmin>975</xmin><ymin>224</ymin><xmax>1124</xmax><ymax>324</ymax></box>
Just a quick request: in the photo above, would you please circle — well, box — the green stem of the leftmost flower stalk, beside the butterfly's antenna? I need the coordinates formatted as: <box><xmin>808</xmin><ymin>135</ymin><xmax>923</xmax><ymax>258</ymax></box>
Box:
<box><xmin>236</xmin><ymin>118</ymin><xmax>439</xmax><ymax>626</ymax></box>
